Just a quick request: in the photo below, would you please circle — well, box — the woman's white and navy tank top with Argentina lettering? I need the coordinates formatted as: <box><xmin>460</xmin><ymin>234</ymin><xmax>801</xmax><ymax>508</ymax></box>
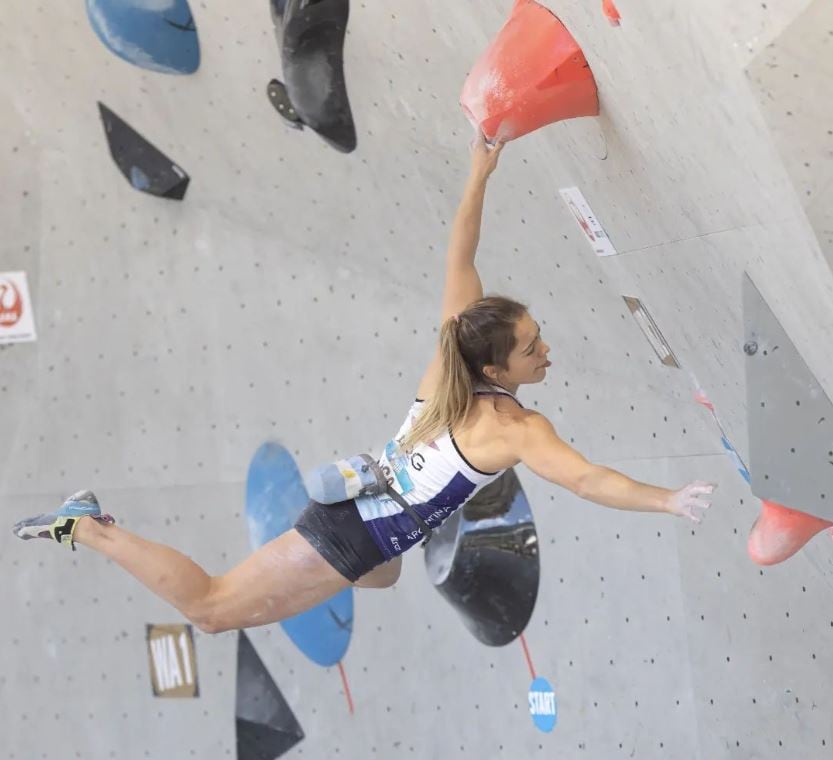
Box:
<box><xmin>356</xmin><ymin>386</ymin><xmax>520</xmax><ymax>560</ymax></box>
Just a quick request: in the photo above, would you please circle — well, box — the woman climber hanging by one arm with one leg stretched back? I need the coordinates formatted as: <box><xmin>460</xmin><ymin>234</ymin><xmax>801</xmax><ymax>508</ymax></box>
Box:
<box><xmin>14</xmin><ymin>134</ymin><xmax>714</xmax><ymax>633</ymax></box>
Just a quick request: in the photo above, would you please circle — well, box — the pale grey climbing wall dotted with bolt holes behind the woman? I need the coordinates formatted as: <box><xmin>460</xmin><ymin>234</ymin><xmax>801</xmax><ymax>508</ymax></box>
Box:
<box><xmin>0</xmin><ymin>0</ymin><xmax>833</xmax><ymax>760</ymax></box>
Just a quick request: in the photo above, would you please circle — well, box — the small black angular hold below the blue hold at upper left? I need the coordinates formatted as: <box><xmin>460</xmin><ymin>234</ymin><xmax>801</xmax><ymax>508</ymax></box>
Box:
<box><xmin>98</xmin><ymin>103</ymin><xmax>190</xmax><ymax>201</ymax></box>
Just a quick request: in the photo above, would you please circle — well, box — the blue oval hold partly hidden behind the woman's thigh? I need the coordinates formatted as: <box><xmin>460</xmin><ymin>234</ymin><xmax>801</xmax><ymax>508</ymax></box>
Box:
<box><xmin>246</xmin><ymin>441</ymin><xmax>353</xmax><ymax>667</ymax></box>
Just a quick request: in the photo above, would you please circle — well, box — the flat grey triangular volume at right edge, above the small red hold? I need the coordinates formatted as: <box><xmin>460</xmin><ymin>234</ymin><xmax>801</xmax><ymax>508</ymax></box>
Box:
<box><xmin>743</xmin><ymin>274</ymin><xmax>833</xmax><ymax>520</ymax></box>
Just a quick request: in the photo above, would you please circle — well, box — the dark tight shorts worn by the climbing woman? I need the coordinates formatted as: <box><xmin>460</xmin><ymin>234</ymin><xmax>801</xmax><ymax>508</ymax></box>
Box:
<box><xmin>295</xmin><ymin>499</ymin><xmax>385</xmax><ymax>583</ymax></box>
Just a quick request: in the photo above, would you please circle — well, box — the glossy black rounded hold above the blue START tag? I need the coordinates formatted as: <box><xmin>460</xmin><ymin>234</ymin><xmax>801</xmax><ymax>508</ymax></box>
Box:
<box><xmin>424</xmin><ymin>470</ymin><xmax>540</xmax><ymax>646</ymax></box>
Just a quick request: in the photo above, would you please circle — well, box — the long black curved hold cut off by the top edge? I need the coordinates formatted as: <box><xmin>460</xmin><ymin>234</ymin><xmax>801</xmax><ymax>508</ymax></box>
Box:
<box><xmin>268</xmin><ymin>0</ymin><xmax>356</xmax><ymax>153</ymax></box>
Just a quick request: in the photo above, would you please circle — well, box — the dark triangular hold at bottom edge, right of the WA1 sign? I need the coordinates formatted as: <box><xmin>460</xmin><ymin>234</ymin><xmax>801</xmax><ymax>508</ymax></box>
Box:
<box><xmin>235</xmin><ymin>631</ymin><xmax>304</xmax><ymax>760</ymax></box>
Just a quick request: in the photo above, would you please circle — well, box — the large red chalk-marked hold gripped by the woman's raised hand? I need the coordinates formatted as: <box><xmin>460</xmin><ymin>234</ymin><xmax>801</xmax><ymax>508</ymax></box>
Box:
<box><xmin>460</xmin><ymin>0</ymin><xmax>599</xmax><ymax>141</ymax></box>
